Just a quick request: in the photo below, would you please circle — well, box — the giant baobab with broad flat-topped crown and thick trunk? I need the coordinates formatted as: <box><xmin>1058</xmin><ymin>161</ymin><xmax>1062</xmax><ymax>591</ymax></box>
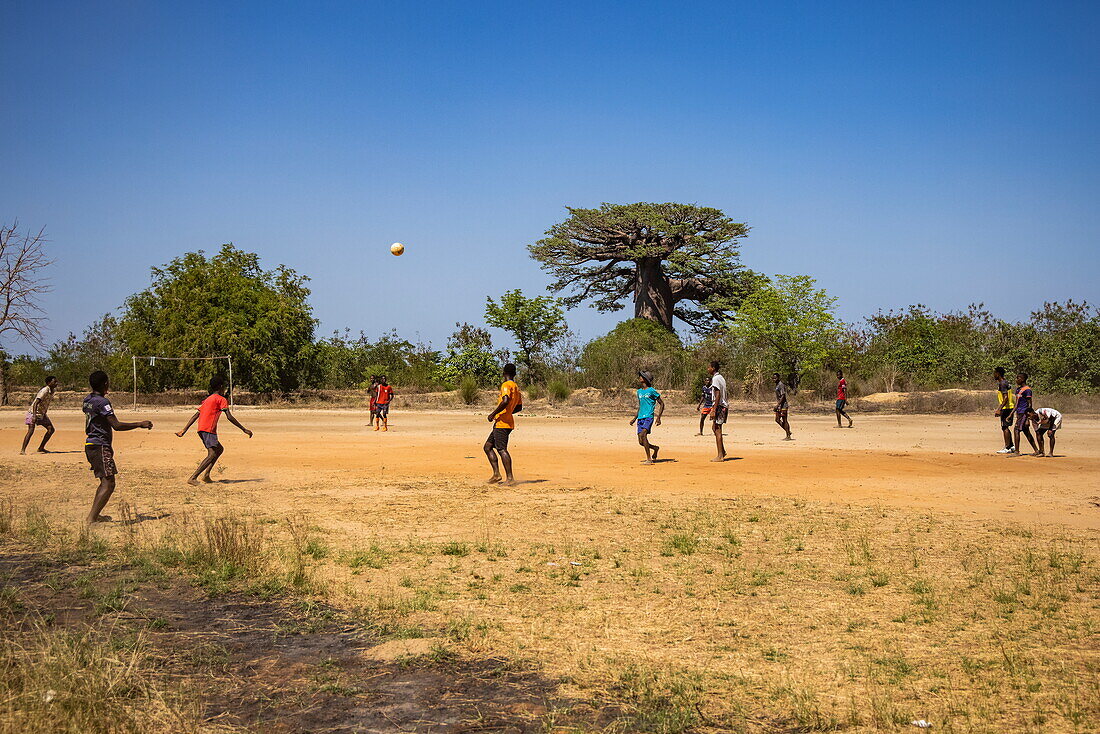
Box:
<box><xmin>528</xmin><ymin>202</ymin><xmax>760</xmax><ymax>332</ymax></box>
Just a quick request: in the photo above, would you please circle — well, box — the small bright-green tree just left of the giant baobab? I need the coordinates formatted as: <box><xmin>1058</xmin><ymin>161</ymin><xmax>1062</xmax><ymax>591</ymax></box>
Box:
<box><xmin>485</xmin><ymin>288</ymin><xmax>569</xmax><ymax>380</ymax></box>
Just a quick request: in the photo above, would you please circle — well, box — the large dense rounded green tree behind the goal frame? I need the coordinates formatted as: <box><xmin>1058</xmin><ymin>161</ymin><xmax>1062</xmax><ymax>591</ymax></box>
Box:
<box><xmin>119</xmin><ymin>244</ymin><xmax>316</xmax><ymax>392</ymax></box>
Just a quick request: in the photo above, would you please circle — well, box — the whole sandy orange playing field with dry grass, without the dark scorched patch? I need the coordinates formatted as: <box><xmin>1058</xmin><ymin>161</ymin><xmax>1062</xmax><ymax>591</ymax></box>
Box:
<box><xmin>0</xmin><ymin>408</ymin><xmax>1100</xmax><ymax>732</ymax></box>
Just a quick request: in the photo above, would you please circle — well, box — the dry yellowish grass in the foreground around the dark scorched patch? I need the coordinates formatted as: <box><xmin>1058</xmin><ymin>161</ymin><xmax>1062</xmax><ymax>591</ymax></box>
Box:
<box><xmin>0</xmin><ymin>483</ymin><xmax>1100</xmax><ymax>732</ymax></box>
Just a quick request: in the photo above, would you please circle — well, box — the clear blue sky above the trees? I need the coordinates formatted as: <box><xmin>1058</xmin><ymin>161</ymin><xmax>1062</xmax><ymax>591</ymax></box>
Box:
<box><xmin>0</xmin><ymin>1</ymin><xmax>1100</xmax><ymax>356</ymax></box>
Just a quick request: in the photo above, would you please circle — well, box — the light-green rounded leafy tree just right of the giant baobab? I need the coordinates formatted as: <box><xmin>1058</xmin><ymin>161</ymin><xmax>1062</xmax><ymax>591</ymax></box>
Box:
<box><xmin>728</xmin><ymin>275</ymin><xmax>844</xmax><ymax>388</ymax></box>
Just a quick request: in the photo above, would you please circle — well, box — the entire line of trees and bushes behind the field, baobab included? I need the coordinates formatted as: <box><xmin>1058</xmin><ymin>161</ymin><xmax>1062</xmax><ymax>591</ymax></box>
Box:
<box><xmin>0</xmin><ymin>204</ymin><xmax>1100</xmax><ymax>395</ymax></box>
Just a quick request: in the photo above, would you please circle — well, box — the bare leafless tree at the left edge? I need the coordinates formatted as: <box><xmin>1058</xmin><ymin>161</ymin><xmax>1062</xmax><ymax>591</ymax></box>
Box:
<box><xmin>0</xmin><ymin>221</ymin><xmax>53</xmax><ymax>405</ymax></box>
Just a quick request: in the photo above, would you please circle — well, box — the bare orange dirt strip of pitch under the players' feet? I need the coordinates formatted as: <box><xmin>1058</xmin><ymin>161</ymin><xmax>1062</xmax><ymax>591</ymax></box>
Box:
<box><xmin>0</xmin><ymin>408</ymin><xmax>1100</xmax><ymax>530</ymax></box>
